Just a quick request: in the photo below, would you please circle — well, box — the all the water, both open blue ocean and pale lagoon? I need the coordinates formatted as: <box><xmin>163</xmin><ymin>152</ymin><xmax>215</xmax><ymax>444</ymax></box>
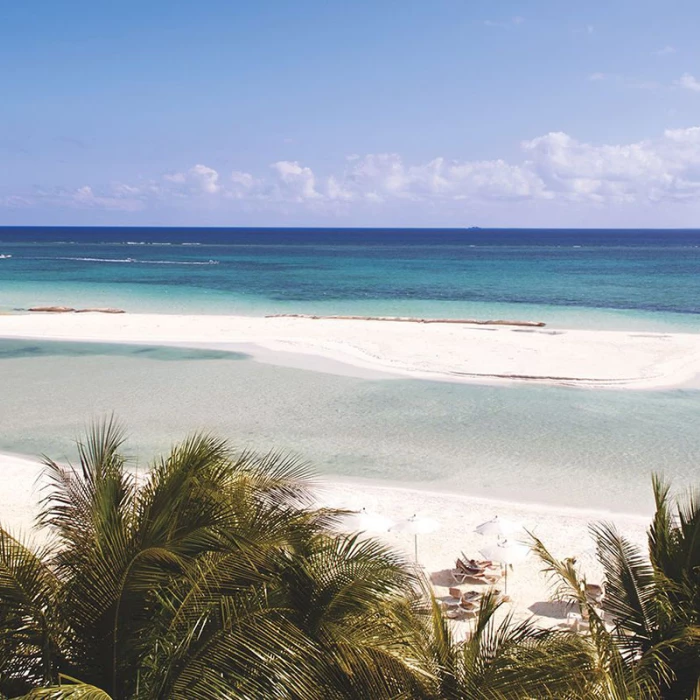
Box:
<box><xmin>0</xmin><ymin>228</ymin><xmax>700</xmax><ymax>512</ymax></box>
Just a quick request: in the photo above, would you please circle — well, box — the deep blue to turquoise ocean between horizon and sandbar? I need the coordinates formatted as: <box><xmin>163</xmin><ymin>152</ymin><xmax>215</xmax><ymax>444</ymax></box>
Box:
<box><xmin>0</xmin><ymin>228</ymin><xmax>700</xmax><ymax>331</ymax></box>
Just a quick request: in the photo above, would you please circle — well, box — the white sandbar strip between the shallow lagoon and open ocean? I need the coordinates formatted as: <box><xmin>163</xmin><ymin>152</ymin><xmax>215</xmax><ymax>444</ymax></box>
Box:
<box><xmin>0</xmin><ymin>313</ymin><xmax>700</xmax><ymax>389</ymax></box>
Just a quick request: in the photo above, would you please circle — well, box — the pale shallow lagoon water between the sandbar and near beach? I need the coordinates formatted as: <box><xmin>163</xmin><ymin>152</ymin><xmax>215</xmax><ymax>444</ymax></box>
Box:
<box><xmin>0</xmin><ymin>340</ymin><xmax>700</xmax><ymax>512</ymax></box>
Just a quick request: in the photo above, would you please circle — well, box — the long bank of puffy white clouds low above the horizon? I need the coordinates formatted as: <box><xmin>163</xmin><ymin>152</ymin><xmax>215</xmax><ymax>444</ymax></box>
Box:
<box><xmin>9</xmin><ymin>127</ymin><xmax>700</xmax><ymax>214</ymax></box>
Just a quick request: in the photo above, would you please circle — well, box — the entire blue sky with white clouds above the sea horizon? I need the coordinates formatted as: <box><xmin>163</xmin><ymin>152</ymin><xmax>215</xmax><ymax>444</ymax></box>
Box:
<box><xmin>0</xmin><ymin>0</ymin><xmax>700</xmax><ymax>228</ymax></box>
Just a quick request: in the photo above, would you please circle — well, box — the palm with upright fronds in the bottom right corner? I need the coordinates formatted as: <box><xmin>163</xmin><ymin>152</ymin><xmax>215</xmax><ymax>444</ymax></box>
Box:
<box><xmin>533</xmin><ymin>477</ymin><xmax>700</xmax><ymax>699</ymax></box>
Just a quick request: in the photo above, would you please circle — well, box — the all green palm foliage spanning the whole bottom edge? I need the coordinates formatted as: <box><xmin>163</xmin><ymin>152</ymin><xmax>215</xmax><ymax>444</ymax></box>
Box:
<box><xmin>0</xmin><ymin>419</ymin><xmax>700</xmax><ymax>700</ymax></box>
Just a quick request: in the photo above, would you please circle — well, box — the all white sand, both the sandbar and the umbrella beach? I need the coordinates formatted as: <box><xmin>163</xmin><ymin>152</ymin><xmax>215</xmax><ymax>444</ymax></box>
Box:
<box><xmin>0</xmin><ymin>313</ymin><xmax>668</xmax><ymax>630</ymax></box>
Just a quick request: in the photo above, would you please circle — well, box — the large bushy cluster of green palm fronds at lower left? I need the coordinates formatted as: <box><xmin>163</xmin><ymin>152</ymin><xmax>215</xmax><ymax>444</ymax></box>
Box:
<box><xmin>0</xmin><ymin>419</ymin><xmax>425</xmax><ymax>700</ymax></box>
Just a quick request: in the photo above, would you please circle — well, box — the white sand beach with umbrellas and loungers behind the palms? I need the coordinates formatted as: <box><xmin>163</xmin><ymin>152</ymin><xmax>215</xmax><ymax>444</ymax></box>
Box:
<box><xmin>0</xmin><ymin>454</ymin><xmax>649</xmax><ymax>632</ymax></box>
